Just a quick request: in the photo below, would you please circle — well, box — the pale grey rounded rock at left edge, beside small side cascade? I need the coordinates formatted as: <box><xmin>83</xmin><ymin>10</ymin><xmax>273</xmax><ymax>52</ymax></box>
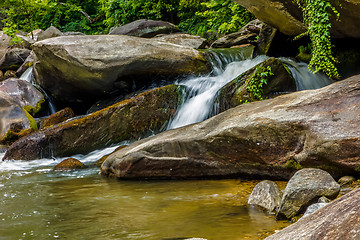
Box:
<box><xmin>0</xmin><ymin>78</ymin><xmax>44</xmax><ymax>108</ymax></box>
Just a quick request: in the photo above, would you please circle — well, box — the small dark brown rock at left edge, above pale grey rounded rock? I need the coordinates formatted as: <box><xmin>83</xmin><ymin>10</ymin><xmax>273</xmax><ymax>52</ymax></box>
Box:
<box><xmin>0</xmin><ymin>48</ymin><xmax>31</xmax><ymax>71</ymax></box>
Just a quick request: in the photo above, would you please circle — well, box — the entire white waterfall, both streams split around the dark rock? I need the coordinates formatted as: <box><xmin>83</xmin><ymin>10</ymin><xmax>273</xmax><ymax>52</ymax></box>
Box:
<box><xmin>167</xmin><ymin>49</ymin><xmax>332</xmax><ymax>129</ymax></box>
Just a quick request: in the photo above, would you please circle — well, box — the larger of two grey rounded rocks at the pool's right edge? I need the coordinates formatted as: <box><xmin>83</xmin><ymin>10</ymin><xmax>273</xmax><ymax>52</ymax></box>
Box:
<box><xmin>277</xmin><ymin>168</ymin><xmax>340</xmax><ymax>218</ymax></box>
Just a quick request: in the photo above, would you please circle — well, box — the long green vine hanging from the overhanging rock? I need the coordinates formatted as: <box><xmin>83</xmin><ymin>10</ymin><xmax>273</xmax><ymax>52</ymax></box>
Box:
<box><xmin>295</xmin><ymin>0</ymin><xmax>340</xmax><ymax>78</ymax></box>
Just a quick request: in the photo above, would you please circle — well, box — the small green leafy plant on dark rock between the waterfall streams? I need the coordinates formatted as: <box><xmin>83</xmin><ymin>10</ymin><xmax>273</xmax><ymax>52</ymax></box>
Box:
<box><xmin>247</xmin><ymin>66</ymin><xmax>274</xmax><ymax>100</ymax></box>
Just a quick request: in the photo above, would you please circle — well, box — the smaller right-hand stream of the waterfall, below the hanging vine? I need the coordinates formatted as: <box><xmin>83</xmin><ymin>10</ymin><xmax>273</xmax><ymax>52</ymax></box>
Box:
<box><xmin>280</xmin><ymin>58</ymin><xmax>334</xmax><ymax>91</ymax></box>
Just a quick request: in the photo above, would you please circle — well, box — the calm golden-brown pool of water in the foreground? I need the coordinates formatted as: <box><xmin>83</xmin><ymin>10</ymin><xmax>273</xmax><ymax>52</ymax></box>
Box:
<box><xmin>0</xmin><ymin>151</ymin><xmax>289</xmax><ymax>240</ymax></box>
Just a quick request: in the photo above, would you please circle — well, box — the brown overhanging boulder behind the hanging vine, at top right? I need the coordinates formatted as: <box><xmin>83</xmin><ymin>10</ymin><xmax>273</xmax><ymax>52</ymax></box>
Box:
<box><xmin>234</xmin><ymin>0</ymin><xmax>360</xmax><ymax>38</ymax></box>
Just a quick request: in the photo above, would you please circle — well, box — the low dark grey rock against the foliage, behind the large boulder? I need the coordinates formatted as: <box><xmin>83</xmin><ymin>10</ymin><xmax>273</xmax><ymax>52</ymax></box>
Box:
<box><xmin>109</xmin><ymin>19</ymin><xmax>180</xmax><ymax>38</ymax></box>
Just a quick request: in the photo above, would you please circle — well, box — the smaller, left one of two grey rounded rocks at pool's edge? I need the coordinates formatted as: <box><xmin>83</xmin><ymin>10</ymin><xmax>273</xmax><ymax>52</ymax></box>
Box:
<box><xmin>248</xmin><ymin>180</ymin><xmax>282</xmax><ymax>212</ymax></box>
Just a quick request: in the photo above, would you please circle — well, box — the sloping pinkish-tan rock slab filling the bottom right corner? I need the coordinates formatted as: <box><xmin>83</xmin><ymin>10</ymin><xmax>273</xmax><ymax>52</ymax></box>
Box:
<box><xmin>265</xmin><ymin>189</ymin><xmax>360</xmax><ymax>240</ymax></box>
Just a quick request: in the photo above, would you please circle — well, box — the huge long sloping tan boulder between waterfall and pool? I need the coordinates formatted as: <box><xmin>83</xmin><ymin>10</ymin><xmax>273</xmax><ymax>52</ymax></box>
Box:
<box><xmin>101</xmin><ymin>76</ymin><xmax>360</xmax><ymax>179</ymax></box>
